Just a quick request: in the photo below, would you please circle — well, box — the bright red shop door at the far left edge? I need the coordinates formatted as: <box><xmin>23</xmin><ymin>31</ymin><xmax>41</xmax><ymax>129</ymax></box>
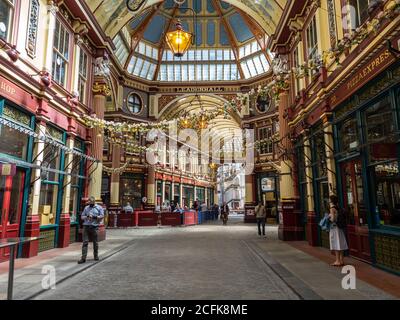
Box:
<box><xmin>0</xmin><ymin>169</ymin><xmax>25</xmax><ymax>261</ymax></box>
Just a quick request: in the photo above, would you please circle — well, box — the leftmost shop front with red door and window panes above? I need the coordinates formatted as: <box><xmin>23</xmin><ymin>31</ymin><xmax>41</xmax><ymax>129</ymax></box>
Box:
<box><xmin>0</xmin><ymin>98</ymin><xmax>34</xmax><ymax>261</ymax></box>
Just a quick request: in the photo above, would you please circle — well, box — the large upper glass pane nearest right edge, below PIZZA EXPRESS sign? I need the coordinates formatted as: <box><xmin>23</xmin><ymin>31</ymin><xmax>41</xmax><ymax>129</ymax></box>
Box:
<box><xmin>365</xmin><ymin>96</ymin><xmax>397</xmax><ymax>163</ymax></box>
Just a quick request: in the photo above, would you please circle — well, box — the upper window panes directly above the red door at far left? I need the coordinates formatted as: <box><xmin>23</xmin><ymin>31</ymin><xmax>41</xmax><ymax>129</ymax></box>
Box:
<box><xmin>0</xmin><ymin>105</ymin><xmax>31</xmax><ymax>160</ymax></box>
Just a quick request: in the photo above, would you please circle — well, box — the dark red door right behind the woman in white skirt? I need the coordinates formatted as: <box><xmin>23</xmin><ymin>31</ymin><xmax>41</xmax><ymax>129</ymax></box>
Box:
<box><xmin>341</xmin><ymin>160</ymin><xmax>371</xmax><ymax>262</ymax></box>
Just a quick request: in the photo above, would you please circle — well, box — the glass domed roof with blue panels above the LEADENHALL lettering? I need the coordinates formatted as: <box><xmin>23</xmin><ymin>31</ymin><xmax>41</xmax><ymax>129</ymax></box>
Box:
<box><xmin>113</xmin><ymin>0</ymin><xmax>271</xmax><ymax>82</ymax></box>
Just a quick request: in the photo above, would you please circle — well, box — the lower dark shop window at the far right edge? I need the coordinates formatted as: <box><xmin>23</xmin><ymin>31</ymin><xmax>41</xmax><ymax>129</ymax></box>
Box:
<box><xmin>372</xmin><ymin>161</ymin><xmax>400</xmax><ymax>227</ymax></box>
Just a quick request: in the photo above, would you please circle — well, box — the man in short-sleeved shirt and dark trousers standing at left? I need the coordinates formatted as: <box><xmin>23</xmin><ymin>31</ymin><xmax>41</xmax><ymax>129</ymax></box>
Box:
<box><xmin>78</xmin><ymin>197</ymin><xmax>104</xmax><ymax>264</ymax></box>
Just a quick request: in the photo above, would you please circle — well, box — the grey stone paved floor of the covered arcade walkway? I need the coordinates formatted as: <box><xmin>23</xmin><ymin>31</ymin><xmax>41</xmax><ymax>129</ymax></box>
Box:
<box><xmin>0</xmin><ymin>217</ymin><xmax>400</xmax><ymax>300</ymax></box>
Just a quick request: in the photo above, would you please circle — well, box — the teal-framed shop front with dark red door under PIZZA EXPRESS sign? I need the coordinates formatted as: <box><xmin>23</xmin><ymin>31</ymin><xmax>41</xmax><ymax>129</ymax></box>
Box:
<box><xmin>333</xmin><ymin>59</ymin><xmax>400</xmax><ymax>272</ymax></box>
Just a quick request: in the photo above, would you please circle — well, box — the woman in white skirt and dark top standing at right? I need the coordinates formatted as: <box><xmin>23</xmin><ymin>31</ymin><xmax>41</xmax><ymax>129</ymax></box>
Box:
<box><xmin>329</xmin><ymin>195</ymin><xmax>348</xmax><ymax>267</ymax></box>
